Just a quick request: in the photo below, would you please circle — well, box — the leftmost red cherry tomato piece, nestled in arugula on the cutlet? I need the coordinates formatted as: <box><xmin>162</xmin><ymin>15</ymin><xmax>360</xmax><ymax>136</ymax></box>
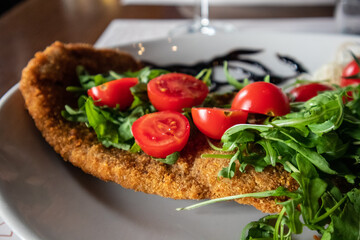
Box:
<box><xmin>88</xmin><ymin>78</ymin><xmax>139</xmax><ymax>110</ymax></box>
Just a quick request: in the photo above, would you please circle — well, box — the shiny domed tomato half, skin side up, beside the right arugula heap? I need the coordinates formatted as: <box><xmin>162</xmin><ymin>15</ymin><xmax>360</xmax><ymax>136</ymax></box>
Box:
<box><xmin>231</xmin><ymin>82</ymin><xmax>290</xmax><ymax>116</ymax></box>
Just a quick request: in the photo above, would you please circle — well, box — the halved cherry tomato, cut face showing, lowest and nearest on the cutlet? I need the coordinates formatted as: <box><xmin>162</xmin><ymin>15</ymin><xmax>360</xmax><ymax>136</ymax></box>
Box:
<box><xmin>131</xmin><ymin>111</ymin><xmax>190</xmax><ymax>158</ymax></box>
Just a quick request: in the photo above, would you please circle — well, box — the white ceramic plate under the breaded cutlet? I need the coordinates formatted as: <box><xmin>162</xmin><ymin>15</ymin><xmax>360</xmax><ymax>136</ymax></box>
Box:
<box><xmin>0</xmin><ymin>32</ymin><xmax>360</xmax><ymax>240</ymax></box>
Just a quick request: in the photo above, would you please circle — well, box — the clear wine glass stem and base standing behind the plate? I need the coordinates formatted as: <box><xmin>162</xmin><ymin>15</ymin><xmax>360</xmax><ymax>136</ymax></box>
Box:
<box><xmin>169</xmin><ymin>0</ymin><xmax>235</xmax><ymax>37</ymax></box>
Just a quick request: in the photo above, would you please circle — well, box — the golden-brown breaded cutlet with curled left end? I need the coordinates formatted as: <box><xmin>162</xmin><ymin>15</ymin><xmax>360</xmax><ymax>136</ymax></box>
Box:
<box><xmin>20</xmin><ymin>42</ymin><xmax>298</xmax><ymax>213</ymax></box>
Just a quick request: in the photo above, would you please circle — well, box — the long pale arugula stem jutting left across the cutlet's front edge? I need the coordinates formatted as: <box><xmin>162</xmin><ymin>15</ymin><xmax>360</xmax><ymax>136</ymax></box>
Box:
<box><xmin>176</xmin><ymin>190</ymin><xmax>276</xmax><ymax>211</ymax></box>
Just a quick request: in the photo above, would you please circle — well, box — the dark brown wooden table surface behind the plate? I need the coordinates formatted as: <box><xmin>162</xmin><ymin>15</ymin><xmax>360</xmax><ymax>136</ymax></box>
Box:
<box><xmin>0</xmin><ymin>0</ymin><xmax>334</xmax><ymax>97</ymax></box>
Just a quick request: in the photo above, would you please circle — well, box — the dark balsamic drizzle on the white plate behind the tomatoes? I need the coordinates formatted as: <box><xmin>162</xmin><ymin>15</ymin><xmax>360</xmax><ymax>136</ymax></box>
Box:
<box><xmin>143</xmin><ymin>49</ymin><xmax>307</xmax><ymax>91</ymax></box>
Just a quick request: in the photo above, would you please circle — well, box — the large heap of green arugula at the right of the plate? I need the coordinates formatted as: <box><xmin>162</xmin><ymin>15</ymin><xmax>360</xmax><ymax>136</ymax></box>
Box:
<box><xmin>178</xmin><ymin>86</ymin><xmax>360</xmax><ymax>240</ymax></box>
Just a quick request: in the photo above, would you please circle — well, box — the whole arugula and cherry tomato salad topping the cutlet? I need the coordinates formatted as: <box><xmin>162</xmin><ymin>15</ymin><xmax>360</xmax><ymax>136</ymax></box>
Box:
<box><xmin>62</xmin><ymin>51</ymin><xmax>360</xmax><ymax>240</ymax></box>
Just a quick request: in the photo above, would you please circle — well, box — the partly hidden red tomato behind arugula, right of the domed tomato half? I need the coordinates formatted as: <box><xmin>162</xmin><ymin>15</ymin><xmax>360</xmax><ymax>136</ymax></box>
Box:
<box><xmin>290</xmin><ymin>83</ymin><xmax>333</xmax><ymax>102</ymax></box>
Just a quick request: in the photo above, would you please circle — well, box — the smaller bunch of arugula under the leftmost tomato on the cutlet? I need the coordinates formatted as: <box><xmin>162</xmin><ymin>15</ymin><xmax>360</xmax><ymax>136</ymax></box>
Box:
<box><xmin>62</xmin><ymin>66</ymin><xmax>168</xmax><ymax>152</ymax></box>
